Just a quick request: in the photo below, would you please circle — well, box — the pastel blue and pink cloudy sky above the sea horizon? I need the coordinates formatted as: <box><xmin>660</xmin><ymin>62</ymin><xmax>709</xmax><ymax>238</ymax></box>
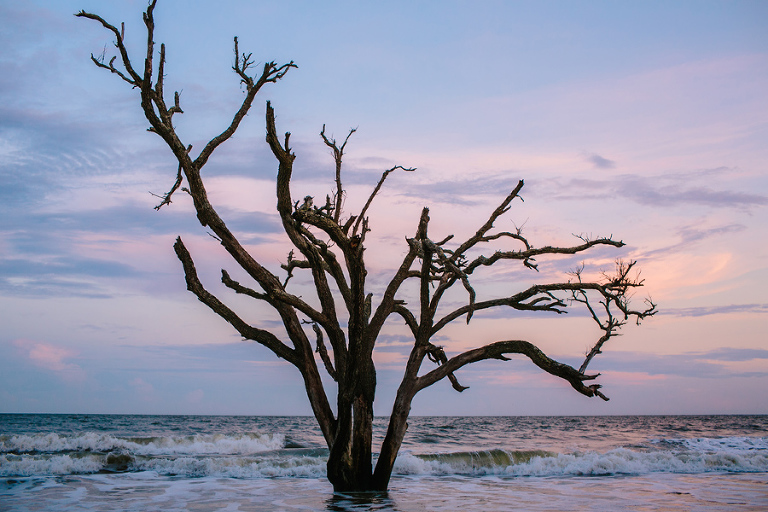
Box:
<box><xmin>0</xmin><ymin>0</ymin><xmax>768</xmax><ymax>415</ymax></box>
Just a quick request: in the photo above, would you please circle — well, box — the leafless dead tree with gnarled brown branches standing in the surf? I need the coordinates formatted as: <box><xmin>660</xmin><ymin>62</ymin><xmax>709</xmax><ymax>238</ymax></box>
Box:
<box><xmin>77</xmin><ymin>0</ymin><xmax>656</xmax><ymax>491</ymax></box>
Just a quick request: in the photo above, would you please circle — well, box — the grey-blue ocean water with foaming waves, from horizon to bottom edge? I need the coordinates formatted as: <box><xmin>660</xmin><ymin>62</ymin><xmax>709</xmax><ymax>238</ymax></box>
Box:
<box><xmin>0</xmin><ymin>414</ymin><xmax>768</xmax><ymax>512</ymax></box>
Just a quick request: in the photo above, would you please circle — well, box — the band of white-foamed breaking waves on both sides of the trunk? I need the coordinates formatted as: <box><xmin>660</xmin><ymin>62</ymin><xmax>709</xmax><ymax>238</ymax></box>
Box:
<box><xmin>0</xmin><ymin>433</ymin><xmax>768</xmax><ymax>478</ymax></box>
